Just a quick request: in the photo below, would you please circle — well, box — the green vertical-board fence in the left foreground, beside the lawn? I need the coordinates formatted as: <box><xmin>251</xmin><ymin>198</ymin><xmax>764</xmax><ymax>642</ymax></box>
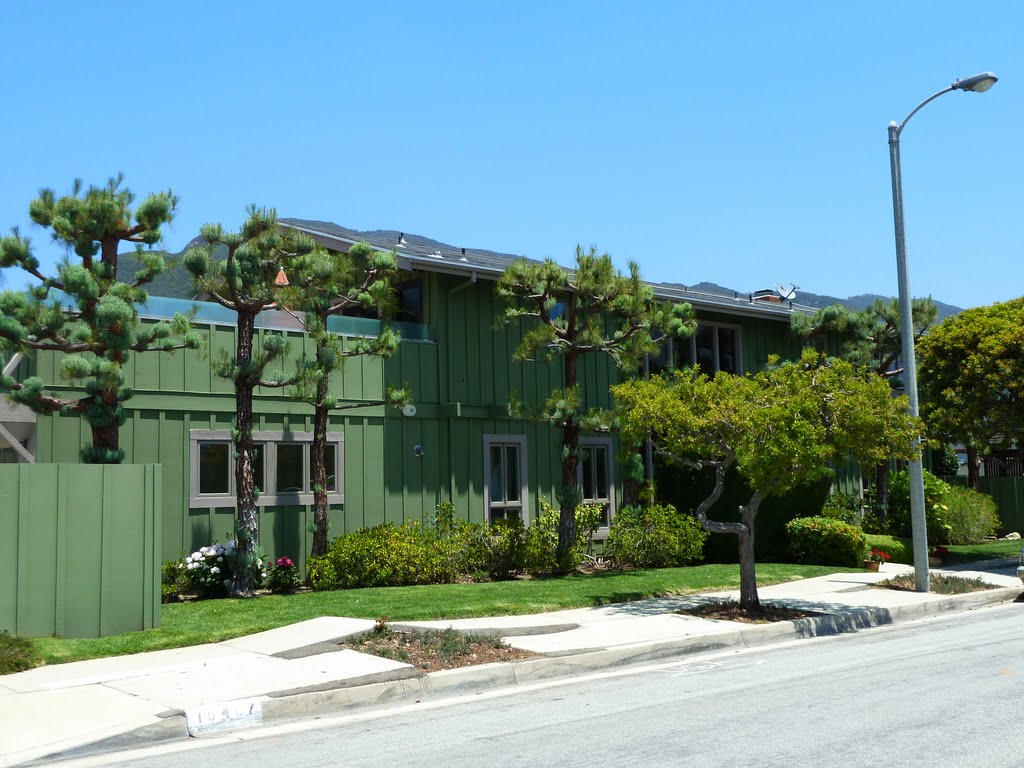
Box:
<box><xmin>0</xmin><ymin>464</ymin><xmax>162</xmax><ymax>638</ymax></box>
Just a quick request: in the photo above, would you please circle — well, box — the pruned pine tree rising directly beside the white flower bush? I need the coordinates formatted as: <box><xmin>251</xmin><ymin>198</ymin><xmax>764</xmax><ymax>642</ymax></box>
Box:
<box><xmin>184</xmin><ymin>206</ymin><xmax>324</xmax><ymax>597</ymax></box>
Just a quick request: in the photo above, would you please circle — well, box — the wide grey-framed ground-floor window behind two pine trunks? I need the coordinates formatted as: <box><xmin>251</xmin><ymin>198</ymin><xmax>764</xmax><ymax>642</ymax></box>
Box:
<box><xmin>188</xmin><ymin>429</ymin><xmax>345</xmax><ymax>507</ymax></box>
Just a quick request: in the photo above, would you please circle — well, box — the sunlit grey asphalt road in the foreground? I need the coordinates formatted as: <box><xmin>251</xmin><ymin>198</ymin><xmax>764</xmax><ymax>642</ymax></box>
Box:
<box><xmin>76</xmin><ymin>603</ymin><xmax>1024</xmax><ymax>768</ymax></box>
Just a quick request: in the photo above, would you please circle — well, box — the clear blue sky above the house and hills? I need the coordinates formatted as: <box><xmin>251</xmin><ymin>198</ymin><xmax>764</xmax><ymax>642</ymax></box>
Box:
<box><xmin>0</xmin><ymin>0</ymin><xmax>1024</xmax><ymax>306</ymax></box>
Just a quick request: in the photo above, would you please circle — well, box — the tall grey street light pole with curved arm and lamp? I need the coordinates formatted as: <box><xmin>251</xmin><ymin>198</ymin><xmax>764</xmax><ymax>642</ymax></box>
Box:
<box><xmin>889</xmin><ymin>72</ymin><xmax>997</xmax><ymax>592</ymax></box>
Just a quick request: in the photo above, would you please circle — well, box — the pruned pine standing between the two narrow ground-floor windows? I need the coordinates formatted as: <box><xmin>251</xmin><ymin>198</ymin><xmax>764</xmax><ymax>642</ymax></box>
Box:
<box><xmin>496</xmin><ymin>246</ymin><xmax>695</xmax><ymax>565</ymax></box>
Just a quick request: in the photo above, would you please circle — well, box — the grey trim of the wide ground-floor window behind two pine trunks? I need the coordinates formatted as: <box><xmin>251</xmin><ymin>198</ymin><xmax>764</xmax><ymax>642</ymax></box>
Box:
<box><xmin>188</xmin><ymin>429</ymin><xmax>345</xmax><ymax>509</ymax></box>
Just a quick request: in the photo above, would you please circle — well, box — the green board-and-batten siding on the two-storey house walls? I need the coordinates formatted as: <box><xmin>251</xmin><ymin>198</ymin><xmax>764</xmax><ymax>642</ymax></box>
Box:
<box><xmin>16</xmin><ymin>272</ymin><xmax>800</xmax><ymax>564</ymax></box>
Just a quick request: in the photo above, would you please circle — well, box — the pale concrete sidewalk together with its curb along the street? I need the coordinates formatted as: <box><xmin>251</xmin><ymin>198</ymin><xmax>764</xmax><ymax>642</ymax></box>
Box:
<box><xmin>0</xmin><ymin>561</ymin><xmax>1022</xmax><ymax>767</ymax></box>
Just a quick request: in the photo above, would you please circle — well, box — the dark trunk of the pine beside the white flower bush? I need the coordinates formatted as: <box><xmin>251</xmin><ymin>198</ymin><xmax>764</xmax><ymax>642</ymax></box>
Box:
<box><xmin>231</xmin><ymin>312</ymin><xmax>259</xmax><ymax>597</ymax></box>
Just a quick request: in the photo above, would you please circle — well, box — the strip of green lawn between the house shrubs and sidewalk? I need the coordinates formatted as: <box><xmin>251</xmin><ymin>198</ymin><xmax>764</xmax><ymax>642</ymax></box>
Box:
<box><xmin>33</xmin><ymin>563</ymin><xmax>852</xmax><ymax>664</ymax></box>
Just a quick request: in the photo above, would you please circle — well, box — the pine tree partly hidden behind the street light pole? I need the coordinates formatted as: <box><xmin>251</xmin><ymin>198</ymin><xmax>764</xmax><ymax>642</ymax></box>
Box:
<box><xmin>791</xmin><ymin>297</ymin><xmax>939</xmax><ymax>519</ymax></box>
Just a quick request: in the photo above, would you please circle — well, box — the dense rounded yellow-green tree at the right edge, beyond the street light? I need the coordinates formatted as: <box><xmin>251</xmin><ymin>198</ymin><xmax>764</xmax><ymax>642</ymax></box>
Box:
<box><xmin>918</xmin><ymin>298</ymin><xmax>1024</xmax><ymax>489</ymax></box>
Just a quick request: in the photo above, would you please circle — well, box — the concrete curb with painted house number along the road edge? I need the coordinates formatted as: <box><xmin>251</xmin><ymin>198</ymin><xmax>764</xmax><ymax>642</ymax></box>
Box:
<box><xmin>20</xmin><ymin>587</ymin><xmax>1021</xmax><ymax>765</ymax></box>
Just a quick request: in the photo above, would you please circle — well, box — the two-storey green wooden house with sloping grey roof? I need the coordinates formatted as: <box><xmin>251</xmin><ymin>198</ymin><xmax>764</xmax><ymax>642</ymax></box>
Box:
<box><xmin>0</xmin><ymin>219</ymin><xmax>815</xmax><ymax>564</ymax></box>
